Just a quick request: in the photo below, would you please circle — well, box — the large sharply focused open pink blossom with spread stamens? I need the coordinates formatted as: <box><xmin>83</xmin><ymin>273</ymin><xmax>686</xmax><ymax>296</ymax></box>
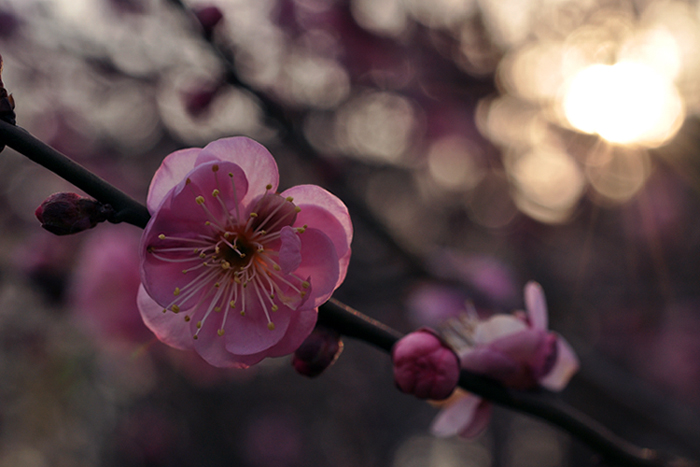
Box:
<box><xmin>138</xmin><ymin>137</ymin><xmax>352</xmax><ymax>368</ymax></box>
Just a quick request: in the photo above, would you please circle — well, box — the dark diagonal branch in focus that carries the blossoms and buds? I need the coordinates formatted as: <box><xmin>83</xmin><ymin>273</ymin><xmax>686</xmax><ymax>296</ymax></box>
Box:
<box><xmin>0</xmin><ymin>121</ymin><xmax>700</xmax><ymax>467</ymax></box>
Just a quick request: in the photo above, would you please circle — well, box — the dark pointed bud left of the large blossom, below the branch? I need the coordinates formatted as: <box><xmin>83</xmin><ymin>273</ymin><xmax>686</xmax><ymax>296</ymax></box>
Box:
<box><xmin>34</xmin><ymin>193</ymin><xmax>114</xmax><ymax>235</ymax></box>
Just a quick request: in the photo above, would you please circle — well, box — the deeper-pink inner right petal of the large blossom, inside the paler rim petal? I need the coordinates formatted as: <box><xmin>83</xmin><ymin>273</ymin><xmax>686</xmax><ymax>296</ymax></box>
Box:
<box><xmin>294</xmin><ymin>228</ymin><xmax>340</xmax><ymax>308</ymax></box>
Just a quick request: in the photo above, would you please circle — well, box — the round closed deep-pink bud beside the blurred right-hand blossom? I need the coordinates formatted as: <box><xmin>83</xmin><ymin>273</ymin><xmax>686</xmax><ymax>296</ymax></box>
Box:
<box><xmin>391</xmin><ymin>328</ymin><xmax>459</xmax><ymax>400</ymax></box>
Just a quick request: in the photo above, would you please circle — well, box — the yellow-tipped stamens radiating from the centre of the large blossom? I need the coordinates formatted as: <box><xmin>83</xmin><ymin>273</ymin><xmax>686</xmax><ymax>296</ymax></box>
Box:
<box><xmin>147</xmin><ymin>165</ymin><xmax>310</xmax><ymax>339</ymax></box>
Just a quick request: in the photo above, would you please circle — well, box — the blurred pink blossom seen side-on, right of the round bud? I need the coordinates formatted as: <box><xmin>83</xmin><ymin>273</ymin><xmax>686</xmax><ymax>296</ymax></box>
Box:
<box><xmin>431</xmin><ymin>282</ymin><xmax>579</xmax><ymax>438</ymax></box>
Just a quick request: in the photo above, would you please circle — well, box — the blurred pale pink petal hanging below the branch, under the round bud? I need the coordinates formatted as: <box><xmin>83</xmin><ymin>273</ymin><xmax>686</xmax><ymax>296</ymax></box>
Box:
<box><xmin>430</xmin><ymin>393</ymin><xmax>490</xmax><ymax>438</ymax></box>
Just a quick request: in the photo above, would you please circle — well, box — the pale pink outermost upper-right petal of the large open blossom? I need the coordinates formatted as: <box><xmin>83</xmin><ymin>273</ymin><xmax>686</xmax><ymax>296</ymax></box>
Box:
<box><xmin>282</xmin><ymin>185</ymin><xmax>353</xmax><ymax>287</ymax></box>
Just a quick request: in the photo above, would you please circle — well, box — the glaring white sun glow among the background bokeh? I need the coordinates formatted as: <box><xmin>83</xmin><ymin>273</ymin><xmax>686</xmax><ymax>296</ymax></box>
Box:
<box><xmin>563</xmin><ymin>62</ymin><xmax>685</xmax><ymax>146</ymax></box>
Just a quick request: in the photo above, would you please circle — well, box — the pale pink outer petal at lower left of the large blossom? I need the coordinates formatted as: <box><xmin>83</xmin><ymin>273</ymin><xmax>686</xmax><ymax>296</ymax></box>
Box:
<box><xmin>136</xmin><ymin>285</ymin><xmax>193</xmax><ymax>349</ymax></box>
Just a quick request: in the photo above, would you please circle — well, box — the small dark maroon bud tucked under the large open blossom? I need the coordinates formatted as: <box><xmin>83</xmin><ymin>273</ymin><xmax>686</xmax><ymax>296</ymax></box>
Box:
<box><xmin>292</xmin><ymin>326</ymin><xmax>343</xmax><ymax>378</ymax></box>
